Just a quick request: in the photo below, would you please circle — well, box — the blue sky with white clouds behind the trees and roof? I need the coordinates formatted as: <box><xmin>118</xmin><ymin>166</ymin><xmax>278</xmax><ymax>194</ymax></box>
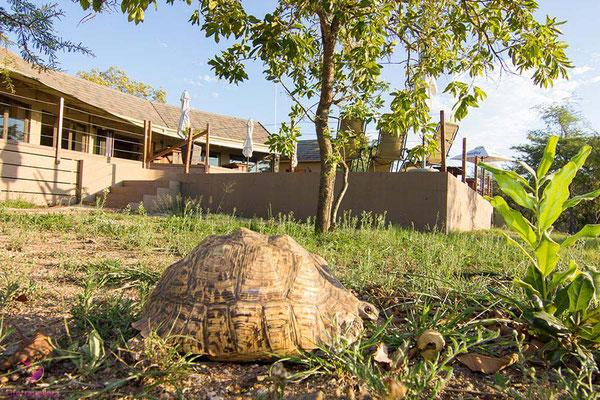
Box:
<box><xmin>12</xmin><ymin>0</ymin><xmax>600</xmax><ymax>159</ymax></box>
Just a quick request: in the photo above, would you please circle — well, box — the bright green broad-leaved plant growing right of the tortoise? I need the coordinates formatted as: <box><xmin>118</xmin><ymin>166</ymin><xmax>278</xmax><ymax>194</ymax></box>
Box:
<box><xmin>480</xmin><ymin>136</ymin><xmax>600</xmax><ymax>350</ymax></box>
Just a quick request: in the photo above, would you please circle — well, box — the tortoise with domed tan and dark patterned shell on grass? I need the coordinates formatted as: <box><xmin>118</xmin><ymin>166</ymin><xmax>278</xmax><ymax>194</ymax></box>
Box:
<box><xmin>133</xmin><ymin>228</ymin><xmax>379</xmax><ymax>361</ymax></box>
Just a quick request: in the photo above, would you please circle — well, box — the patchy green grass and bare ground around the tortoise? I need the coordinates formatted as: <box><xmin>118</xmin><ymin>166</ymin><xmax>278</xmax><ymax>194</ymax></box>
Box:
<box><xmin>0</xmin><ymin>204</ymin><xmax>600</xmax><ymax>399</ymax></box>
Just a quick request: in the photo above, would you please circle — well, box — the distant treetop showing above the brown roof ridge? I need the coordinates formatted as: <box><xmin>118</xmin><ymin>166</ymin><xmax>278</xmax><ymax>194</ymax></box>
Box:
<box><xmin>77</xmin><ymin>67</ymin><xmax>167</xmax><ymax>103</ymax></box>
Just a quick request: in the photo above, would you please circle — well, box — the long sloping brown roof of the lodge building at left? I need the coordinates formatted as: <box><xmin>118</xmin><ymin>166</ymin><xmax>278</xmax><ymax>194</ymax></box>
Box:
<box><xmin>0</xmin><ymin>48</ymin><xmax>269</xmax><ymax>144</ymax></box>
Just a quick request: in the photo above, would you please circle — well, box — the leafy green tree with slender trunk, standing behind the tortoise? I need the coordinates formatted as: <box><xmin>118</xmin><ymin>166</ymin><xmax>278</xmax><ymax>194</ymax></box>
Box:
<box><xmin>80</xmin><ymin>0</ymin><xmax>570</xmax><ymax>231</ymax></box>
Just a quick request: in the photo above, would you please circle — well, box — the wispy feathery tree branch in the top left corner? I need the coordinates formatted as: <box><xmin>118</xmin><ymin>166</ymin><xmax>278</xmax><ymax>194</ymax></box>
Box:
<box><xmin>0</xmin><ymin>0</ymin><xmax>91</xmax><ymax>71</ymax></box>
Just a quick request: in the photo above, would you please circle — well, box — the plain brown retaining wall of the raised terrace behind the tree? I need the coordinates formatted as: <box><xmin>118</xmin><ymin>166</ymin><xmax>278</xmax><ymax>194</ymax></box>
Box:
<box><xmin>179</xmin><ymin>172</ymin><xmax>492</xmax><ymax>232</ymax></box>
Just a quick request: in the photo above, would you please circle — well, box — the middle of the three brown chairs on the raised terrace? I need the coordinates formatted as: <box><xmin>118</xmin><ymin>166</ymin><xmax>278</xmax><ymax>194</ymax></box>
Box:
<box><xmin>369</xmin><ymin>130</ymin><xmax>408</xmax><ymax>172</ymax></box>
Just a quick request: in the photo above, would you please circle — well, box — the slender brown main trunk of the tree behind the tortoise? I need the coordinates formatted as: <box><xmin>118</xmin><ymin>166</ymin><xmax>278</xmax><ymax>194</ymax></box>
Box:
<box><xmin>315</xmin><ymin>11</ymin><xmax>338</xmax><ymax>232</ymax></box>
